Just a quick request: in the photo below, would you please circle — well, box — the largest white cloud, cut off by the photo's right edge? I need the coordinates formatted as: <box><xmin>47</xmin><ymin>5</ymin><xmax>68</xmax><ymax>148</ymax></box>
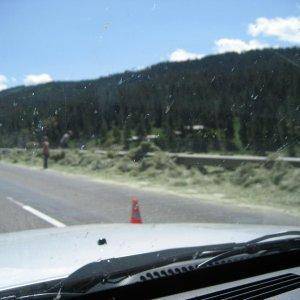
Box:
<box><xmin>248</xmin><ymin>17</ymin><xmax>300</xmax><ymax>43</ymax></box>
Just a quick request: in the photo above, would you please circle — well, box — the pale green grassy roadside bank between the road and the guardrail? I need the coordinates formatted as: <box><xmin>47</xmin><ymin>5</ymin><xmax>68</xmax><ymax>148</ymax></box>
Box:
<box><xmin>0</xmin><ymin>143</ymin><xmax>300</xmax><ymax>215</ymax></box>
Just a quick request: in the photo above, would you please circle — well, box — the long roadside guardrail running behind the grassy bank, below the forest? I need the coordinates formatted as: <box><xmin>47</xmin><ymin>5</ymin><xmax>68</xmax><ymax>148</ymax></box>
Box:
<box><xmin>0</xmin><ymin>148</ymin><xmax>300</xmax><ymax>168</ymax></box>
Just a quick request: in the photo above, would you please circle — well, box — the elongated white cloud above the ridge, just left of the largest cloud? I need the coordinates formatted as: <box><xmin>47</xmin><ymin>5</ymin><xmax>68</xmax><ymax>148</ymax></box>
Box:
<box><xmin>215</xmin><ymin>38</ymin><xmax>269</xmax><ymax>53</ymax></box>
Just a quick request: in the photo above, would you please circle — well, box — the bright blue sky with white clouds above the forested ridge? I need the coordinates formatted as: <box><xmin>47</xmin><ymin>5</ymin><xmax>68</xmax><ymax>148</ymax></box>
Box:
<box><xmin>0</xmin><ymin>0</ymin><xmax>300</xmax><ymax>89</ymax></box>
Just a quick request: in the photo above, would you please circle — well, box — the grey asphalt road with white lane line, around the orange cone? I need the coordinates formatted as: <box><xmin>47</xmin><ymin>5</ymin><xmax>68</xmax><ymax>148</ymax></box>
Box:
<box><xmin>0</xmin><ymin>163</ymin><xmax>300</xmax><ymax>232</ymax></box>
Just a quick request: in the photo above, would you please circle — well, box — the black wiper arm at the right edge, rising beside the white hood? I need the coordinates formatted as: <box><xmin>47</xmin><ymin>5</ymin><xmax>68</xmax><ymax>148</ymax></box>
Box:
<box><xmin>198</xmin><ymin>231</ymin><xmax>300</xmax><ymax>268</ymax></box>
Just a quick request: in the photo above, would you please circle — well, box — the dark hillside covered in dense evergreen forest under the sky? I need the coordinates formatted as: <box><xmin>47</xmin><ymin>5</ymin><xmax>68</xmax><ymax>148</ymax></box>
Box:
<box><xmin>0</xmin><ymin>48</ymin><xmax>300</xmax><ymax>155</ymax></box>
